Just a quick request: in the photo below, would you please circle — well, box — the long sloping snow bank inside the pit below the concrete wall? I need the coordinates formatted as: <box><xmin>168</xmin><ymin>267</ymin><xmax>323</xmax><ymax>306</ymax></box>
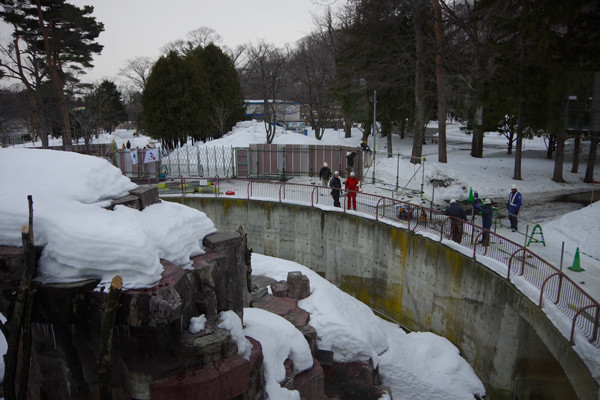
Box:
<box><xmin>251</xmin><ymin>253</ymin><xmax>485</xmax><ymax>400</ymax></box>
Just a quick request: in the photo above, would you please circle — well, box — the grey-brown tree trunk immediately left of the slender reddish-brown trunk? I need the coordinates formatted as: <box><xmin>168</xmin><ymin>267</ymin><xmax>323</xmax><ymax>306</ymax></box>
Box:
<box><xmin>410</xmin><ymin>0</ymin><xmax>425</xmax><ymax>164</ymax></box>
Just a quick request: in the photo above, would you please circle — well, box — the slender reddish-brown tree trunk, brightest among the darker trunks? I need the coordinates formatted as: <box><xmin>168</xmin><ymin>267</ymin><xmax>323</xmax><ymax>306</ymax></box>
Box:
<box><xmin>431</xmin><ymin>0</ymin><xmax>448</xmax><ymax>163</ymax></box>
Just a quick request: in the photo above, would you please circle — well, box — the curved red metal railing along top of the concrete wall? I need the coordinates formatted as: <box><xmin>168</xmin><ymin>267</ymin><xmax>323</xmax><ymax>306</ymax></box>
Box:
<box><xmin>151</xmin><ymin>177</ymin><xmax>600</xmax><ymax>347</ymax></box>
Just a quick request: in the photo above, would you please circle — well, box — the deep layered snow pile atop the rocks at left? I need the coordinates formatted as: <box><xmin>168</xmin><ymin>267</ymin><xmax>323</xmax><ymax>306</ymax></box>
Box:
<box><xmin>0</xmin><ymin>149</ymin><xmax>216</xmax><ymax>288</ymax></box>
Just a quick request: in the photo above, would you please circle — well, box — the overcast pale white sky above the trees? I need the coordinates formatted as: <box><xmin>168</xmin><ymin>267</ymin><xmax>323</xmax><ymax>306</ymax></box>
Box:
<box><xmin>0</xmin><ymin>0</ymin><xmax>342</xmax><ymax>82</ymax></box>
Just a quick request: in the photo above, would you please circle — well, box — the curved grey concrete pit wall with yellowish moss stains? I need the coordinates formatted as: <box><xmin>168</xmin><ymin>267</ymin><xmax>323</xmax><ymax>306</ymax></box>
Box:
<box><xmin>174</xmin><ymin>197</ymin><xmax>600</xmax><ymax>400</ymax></box>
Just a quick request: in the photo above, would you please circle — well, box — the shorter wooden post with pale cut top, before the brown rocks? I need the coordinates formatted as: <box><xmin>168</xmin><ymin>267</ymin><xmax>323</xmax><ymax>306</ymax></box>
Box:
<box><xmin>98</xmin><ymin>275</ymin><xmax>123</xmax><ymax>400</ymax></box>
